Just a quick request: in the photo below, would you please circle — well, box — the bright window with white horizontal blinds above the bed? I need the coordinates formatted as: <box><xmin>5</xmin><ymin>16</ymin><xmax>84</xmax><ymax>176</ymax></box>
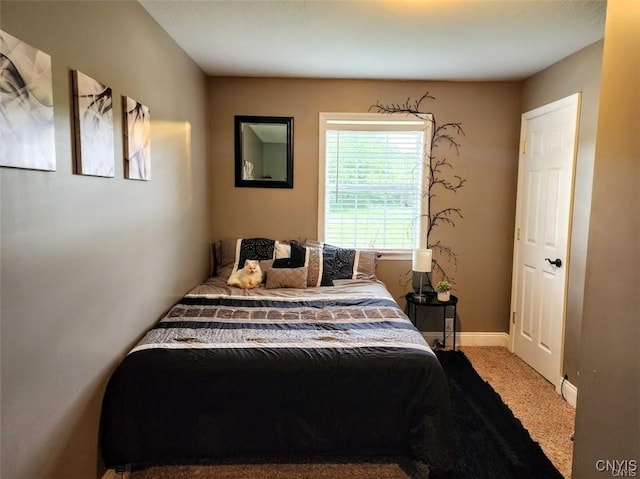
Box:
<box><xmin>318</xmin><ymin>113</ymin><xmax>431</xmax><ymax>253</ymax></box>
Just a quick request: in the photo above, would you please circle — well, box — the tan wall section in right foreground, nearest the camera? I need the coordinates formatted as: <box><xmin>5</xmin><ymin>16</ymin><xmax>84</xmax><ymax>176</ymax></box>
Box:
<box><xmin>573</xmin><ymin>0</ymin><xmax>640</xmax><ymax>478</ymax></box>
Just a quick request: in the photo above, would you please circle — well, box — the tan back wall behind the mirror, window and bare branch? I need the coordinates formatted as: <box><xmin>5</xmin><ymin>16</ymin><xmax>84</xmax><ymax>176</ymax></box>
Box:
<box><xmin>209</xmin><ymin>78</ymin><xmax>521</xmax><ymax>332</ymax></box>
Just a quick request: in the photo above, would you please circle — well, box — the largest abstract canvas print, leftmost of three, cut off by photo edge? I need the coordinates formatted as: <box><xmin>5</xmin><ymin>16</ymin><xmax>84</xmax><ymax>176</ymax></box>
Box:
<box><xmin>0</xmin><ymin>30</ymin><xmax>56</xmax><ymax>171</ymax></box>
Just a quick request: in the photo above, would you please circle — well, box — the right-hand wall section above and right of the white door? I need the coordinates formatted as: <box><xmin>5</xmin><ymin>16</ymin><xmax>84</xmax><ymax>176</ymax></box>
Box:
<box><xmin>522</xmin><ymin>41</ymin><xmax>603</xmax><ymax>387</ymax></box>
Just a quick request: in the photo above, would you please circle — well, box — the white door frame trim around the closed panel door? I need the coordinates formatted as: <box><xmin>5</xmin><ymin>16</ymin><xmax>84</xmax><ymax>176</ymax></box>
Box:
<box><xmin>509</xmin><ymin>92</ymin><xmax>582</xmax><ymax>394</ymax></box>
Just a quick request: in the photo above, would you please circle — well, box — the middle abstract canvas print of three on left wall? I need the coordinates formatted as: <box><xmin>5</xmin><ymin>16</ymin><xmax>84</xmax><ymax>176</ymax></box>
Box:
<box><xmin>73</xmin><ymin>71</ymin><xmax>115</xmax><ymax>177</ymax></box>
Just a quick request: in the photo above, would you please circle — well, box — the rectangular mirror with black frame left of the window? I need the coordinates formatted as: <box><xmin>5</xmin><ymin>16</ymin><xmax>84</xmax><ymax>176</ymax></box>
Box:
<box><xmin>235</xmin><ymin>115</ymin><xmax>293</xmax><ymax>188</ymax></box>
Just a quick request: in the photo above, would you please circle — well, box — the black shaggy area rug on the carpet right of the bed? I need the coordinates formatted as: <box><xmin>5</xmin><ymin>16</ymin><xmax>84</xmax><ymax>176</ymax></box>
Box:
<box><xmin>436</xmin><ymin>351</ymin><xmax>562</xmax><ymax>479</ymax></box>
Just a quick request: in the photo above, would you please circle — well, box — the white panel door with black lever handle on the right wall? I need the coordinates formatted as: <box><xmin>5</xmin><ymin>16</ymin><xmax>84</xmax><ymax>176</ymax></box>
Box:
<box><xmin>510</xmin><ymin>93</ymin><xmax>580</xmax><ymax>388</ymax></box>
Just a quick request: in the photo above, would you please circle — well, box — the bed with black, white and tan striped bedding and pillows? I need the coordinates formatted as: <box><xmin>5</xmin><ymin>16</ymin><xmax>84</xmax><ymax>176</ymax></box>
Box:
<box><xmin>100</xmin><ymin>240</ymin><xmax>454</xmax><ymax>477</ymax></box>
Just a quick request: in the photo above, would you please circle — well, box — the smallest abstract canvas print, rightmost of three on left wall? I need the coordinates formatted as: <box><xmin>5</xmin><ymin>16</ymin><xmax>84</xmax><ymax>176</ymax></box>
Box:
<box><xmin>122</xmin><ymin>96</ymin><xmax>151</xmax><ymax>180</ymax></box>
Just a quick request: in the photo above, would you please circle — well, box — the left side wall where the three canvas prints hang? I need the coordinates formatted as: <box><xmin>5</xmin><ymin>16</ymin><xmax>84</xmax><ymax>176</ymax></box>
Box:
<box><xmin>0</xmin><ymin>1</ymin><xmax>210</xmax><ymax>479</ymax></box>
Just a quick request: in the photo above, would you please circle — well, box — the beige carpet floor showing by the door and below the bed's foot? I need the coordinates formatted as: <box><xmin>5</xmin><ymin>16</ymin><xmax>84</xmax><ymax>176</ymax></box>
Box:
<box><xmin>111</xmin><ymin>347</ymin><xmax>575</xmax><ymax>479</ymax></box>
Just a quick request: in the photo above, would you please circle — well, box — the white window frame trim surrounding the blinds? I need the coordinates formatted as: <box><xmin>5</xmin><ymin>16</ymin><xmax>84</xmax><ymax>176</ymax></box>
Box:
<box><xmin>318</xmin><ymin>112</ymin><xmax>433</xmax><ymax>260</ymax></box>
